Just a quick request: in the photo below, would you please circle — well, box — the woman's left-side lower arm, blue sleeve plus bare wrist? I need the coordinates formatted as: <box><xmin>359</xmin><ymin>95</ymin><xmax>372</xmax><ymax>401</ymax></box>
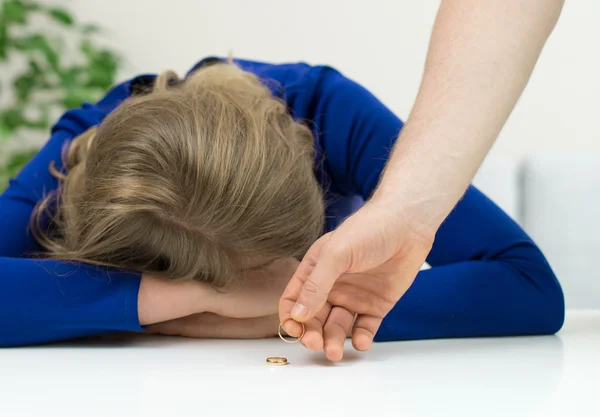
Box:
<box><xmin>0</xmin><ymin>258</ymin><xmax>213</xmax><ymax>346</ymax></box>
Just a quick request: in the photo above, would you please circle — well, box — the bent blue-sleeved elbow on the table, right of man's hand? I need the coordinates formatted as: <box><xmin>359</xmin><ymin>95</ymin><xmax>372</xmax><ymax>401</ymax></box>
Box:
<box><xmin>375</xmin><ymin>187</ymin><xmax>564</xmax><ymax>341</ymax></box>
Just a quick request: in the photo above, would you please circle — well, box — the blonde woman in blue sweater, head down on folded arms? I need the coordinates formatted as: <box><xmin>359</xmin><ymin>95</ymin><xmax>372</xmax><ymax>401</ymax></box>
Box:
<box><xmin>0</xmin><ymin>58</ymin><xmax>564</xmax><ymax>359</ymax></box>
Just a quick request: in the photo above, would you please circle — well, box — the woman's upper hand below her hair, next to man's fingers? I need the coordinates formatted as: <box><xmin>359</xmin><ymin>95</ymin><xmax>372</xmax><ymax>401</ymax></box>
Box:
<box><xmin>205</xmin><ymin>254</ymin><xmax>300</xmax><ymax>318</ymax></box>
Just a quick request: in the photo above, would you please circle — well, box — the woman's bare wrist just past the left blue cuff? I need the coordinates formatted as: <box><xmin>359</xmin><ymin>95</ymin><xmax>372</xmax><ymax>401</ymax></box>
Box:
<box><xmin>138</xmin><ymin>274</ymin><xmax>215</xmax><ymax>326</ymax></box>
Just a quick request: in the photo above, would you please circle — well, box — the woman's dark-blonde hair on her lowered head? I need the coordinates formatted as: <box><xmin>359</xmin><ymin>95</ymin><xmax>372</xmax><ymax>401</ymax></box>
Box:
<box><xmin>32</xmin><ymin>63</ymin><xmax>324</xmax><ymax>287</ymax></box>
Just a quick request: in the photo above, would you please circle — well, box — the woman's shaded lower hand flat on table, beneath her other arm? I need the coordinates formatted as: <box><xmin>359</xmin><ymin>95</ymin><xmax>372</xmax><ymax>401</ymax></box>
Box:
<box><xmin>146</xmin><ymin>313</ymin><xmax>279</xmax><ymax>339</ymax></box>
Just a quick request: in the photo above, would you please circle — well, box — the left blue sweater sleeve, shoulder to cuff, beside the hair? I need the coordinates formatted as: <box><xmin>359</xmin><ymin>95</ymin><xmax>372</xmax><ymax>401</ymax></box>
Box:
<box><xmin>0</xmin><ymin>79</ymin><xmax>141</xmax><ymax>346</ymax></box>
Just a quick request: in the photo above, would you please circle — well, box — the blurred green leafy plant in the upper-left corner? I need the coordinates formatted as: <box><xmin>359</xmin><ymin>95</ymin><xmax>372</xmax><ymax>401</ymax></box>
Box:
<box><xmin>0</xmin><ymin>0</ymin><xmax>121</xmax><ymax>148</ymax></box>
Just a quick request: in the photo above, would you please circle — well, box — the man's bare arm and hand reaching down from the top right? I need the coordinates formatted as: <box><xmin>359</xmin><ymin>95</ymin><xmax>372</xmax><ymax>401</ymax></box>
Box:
<box><xmin>279</xmin><ymin>0</ymin><xmax>563</xmax><ymax>360</ymax></box>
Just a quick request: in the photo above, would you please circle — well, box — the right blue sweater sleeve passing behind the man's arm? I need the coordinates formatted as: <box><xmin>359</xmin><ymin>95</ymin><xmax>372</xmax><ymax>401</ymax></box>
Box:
<box><xmin>305</xmin><ymin>67</ymin><xmax>564</xmax><ymax>341</ymax></box>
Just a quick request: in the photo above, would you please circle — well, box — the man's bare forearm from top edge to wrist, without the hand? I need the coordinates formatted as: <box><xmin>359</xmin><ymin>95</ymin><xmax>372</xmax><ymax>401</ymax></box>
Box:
<box><xmin>374</xmin><ymin>0</ymin><xmax>563</xmax><ymax>233</ymax></box>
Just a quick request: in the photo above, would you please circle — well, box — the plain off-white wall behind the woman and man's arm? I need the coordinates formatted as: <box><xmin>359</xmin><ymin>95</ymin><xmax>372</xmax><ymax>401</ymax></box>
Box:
<box><xmin>46</xmin><ymin>0</ymin><xmax>600</xmax><ymax>159</ymax></box>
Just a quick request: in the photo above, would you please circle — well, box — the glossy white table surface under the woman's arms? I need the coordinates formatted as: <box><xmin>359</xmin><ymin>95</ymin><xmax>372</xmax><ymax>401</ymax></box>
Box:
<box><xmin>0</xmin><ymin>311</ymin><xmax>600</xmax><ymax>417</ymax></box>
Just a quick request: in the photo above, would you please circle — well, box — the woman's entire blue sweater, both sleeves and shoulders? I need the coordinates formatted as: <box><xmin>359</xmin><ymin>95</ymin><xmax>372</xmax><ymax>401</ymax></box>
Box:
<box><xmin>0</xmin><ymin>60</ymin><xmax>564</xmax><ymax>346</ymax></box>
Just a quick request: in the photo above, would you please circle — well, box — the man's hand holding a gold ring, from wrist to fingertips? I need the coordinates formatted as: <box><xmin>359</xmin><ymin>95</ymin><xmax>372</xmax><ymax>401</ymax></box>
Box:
<box><xmin>279</xmin><ymin>202</ymin><xmax>433</xmax><ymax>360</ymax></box>
